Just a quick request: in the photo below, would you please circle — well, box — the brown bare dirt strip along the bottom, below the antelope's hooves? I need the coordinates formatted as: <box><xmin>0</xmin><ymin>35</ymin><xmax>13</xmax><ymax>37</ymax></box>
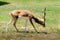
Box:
<box><xmin>0</xmin><ymin>32</ymin><xmax>59</xmax><ymax>40</ymax></box>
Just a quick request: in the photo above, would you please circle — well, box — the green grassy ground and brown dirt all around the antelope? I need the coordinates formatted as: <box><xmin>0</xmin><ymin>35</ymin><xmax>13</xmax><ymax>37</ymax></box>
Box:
<box><xmin>0</xmin><ymin>0</ymin><xmax>60</xmax><ymax>40</ymax></box>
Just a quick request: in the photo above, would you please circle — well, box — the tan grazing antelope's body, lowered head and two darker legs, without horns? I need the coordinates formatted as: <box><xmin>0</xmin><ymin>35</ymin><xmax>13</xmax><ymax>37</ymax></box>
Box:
<box><xmin>6</xmin><ymin>7</ymin><xmax>45</xmax><ymax>32</ymax></box>
